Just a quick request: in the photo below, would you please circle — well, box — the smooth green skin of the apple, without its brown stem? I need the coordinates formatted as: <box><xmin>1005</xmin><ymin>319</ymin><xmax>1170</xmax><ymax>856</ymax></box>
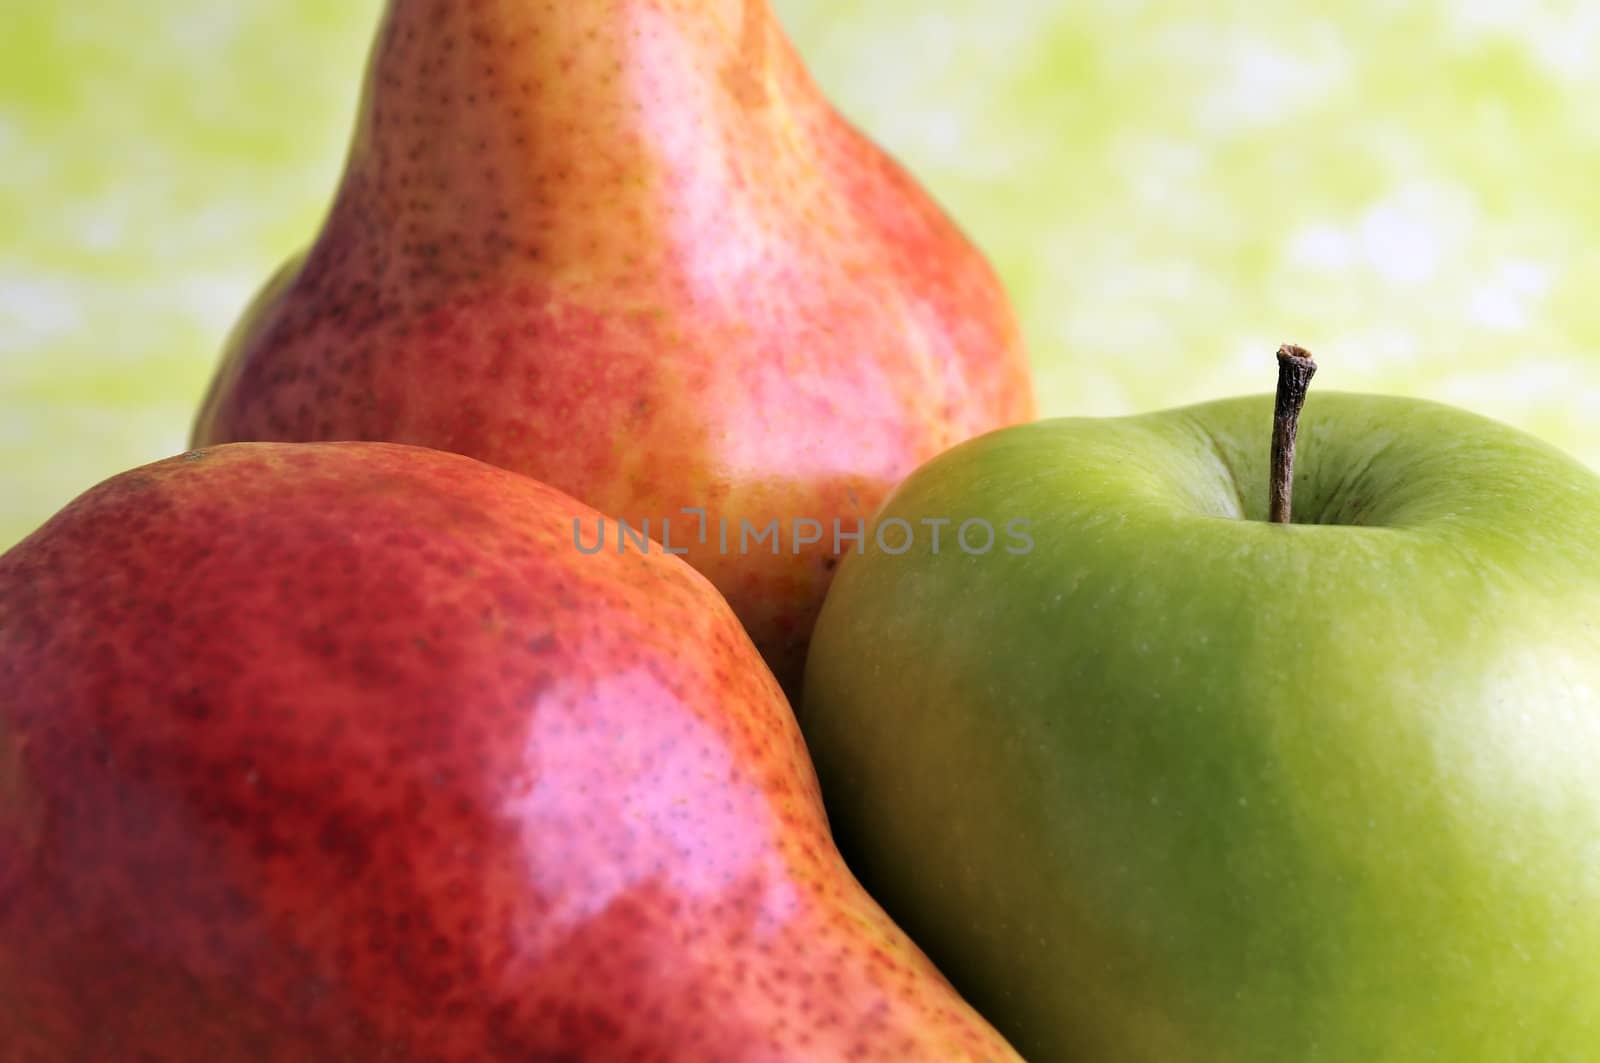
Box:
<box><xmin>800</xmin><ymin>394</ymin><xmax>1600</xmax><ymax>1063</ymax></box>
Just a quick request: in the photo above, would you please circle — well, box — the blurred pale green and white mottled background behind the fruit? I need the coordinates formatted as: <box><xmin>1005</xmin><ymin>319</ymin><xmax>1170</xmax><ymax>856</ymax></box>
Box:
<box><xmin>0</xmin><ymin>0</ymin><xmax>1600</xmax><ymax>548</ymax></box>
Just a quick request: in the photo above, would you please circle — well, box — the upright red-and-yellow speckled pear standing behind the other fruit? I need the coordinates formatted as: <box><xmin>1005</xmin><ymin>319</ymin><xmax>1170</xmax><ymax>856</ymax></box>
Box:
<box><xmin>194</xmin><ymin>0</ymin><xmax>1034</xmax><ymax>684</ymax></box>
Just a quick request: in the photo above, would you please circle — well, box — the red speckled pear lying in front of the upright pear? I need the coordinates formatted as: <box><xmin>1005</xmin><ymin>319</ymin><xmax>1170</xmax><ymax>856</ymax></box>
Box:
<box><xmin>0</xmin><ymin>443</ymin><xmax>1014</xmax><ymax>1063</ymax></box>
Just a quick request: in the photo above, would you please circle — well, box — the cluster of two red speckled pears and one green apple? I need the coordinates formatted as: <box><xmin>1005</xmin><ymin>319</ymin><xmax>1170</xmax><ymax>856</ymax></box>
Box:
<box><xmin>0</xmin><ymin>0</ymin><xmax>1600</xmax><ymax>1063</ymax></box>
